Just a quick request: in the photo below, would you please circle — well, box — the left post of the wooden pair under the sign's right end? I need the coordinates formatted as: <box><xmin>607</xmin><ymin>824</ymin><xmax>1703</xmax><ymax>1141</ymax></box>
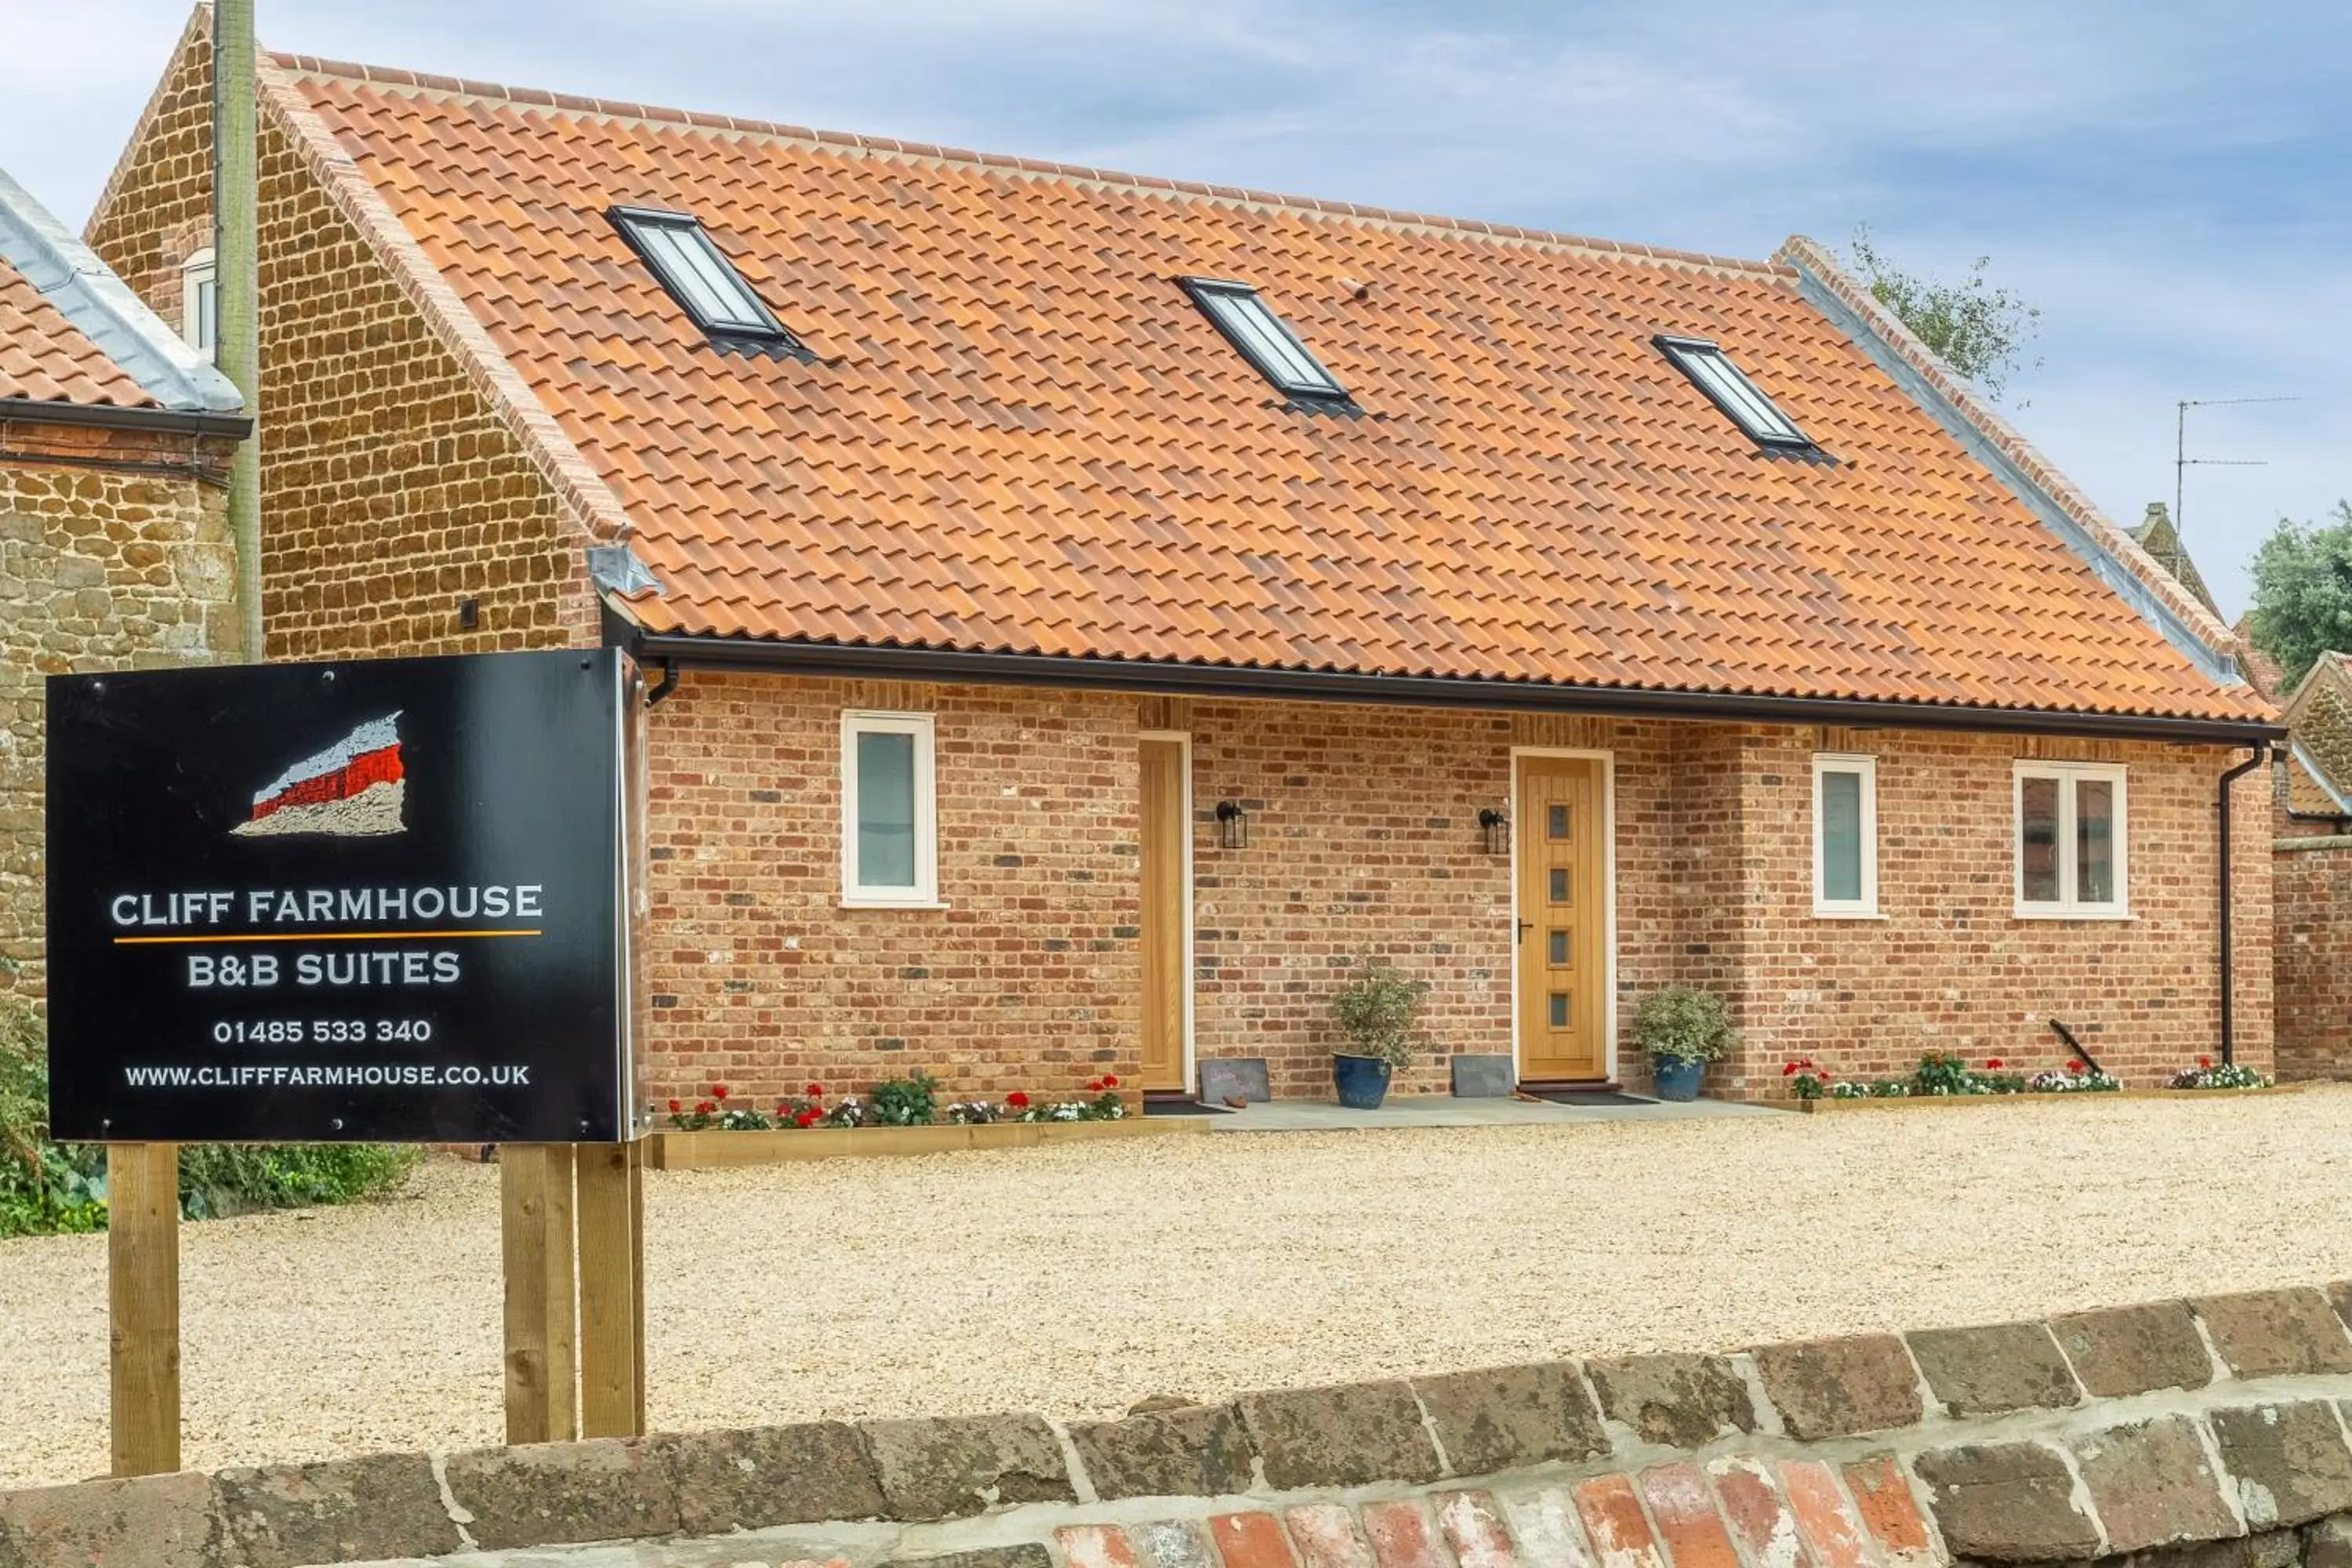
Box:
<box><xmin>499</xmin><ymin>1142</ymin><xmax>579</xmax><ymax>1443</ymax></box>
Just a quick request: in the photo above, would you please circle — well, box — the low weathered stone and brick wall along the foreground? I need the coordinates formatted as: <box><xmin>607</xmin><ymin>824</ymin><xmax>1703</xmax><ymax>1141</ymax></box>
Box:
<box><xmin>13</xmin><ymin>1283</ymin><xmax>2352</xmax><ymax>1568</ymax></box>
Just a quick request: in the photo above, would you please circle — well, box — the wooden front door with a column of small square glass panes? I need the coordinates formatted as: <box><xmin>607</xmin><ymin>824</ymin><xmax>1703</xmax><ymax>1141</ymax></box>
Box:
<box><xmin>1517</xmin><ymin>757</ymin><xmax>1609</xmax><ymax>1081</ymax></box>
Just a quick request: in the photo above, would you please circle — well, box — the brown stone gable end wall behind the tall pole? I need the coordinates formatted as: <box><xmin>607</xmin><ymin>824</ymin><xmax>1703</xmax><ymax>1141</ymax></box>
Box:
<box><xmin>89</xmin><ymin>28</ymin><xmax>597</xmax><ymax>659</ymax></box>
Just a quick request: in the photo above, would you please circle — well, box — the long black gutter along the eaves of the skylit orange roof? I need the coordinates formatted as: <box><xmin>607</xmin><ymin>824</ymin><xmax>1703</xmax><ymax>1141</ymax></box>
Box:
<box><xmin>604</xmin><ymin>612</ymin><xmax>2286</xmax><ymax>746</ymax></box>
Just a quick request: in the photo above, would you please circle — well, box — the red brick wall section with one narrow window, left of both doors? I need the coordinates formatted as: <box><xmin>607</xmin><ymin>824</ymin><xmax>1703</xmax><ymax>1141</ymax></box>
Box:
<box><xmin>649</xmin><ymin>673</ymin><xmax>1143</xmax><ymax>1100</ymax></box>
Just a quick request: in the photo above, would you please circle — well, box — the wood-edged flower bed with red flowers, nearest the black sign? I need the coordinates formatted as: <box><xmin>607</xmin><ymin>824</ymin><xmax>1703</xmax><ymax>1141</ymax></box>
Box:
<box><xmin>649</xmin><ymin>1072</ymin><xmax>1209</xmax><ymax>1171</ymax></box>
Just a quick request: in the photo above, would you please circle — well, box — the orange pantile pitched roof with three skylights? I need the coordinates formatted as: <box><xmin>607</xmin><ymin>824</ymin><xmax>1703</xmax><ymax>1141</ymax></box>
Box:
<box><xmin>266</xmin><ymin>56</ymin><xmax>2267</xmax><ymax>720</ymax></box>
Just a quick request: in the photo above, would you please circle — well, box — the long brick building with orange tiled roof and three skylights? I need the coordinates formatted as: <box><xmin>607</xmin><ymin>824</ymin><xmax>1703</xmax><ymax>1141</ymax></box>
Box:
<box><xmin>92</xmin><ymin>26</ymin><xmax>2277</xmax><ymax>1095</ymax></box>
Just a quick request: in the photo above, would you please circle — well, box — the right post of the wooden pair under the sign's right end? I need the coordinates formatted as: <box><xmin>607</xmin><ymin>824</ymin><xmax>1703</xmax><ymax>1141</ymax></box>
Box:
<box><xmin>574</xmin><ymin>1142</ymin><xmax>644</xmax><ymax>1436</ymax></box>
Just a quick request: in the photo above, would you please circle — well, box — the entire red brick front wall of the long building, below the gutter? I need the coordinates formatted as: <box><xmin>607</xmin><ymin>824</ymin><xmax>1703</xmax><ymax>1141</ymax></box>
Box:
<box><xmin>635</xmin><ymin>675</ymin><xmax>2270</xmax><ymax>1098</ymax></box>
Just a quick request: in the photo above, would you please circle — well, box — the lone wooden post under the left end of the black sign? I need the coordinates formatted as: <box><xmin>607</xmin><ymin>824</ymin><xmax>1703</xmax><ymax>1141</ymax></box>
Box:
<box><xmin>106</xmin><ymin>1142</ymin><xmax>179</xmax><ymax>1476</ymax></box>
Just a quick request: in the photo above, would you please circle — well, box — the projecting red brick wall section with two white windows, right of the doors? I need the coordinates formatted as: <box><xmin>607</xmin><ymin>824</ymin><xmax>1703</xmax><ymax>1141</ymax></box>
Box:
<box><xmin>1722</xmin><ymin>729</ymin><xmax>2270</xmax><ymax>1095</ymax></box>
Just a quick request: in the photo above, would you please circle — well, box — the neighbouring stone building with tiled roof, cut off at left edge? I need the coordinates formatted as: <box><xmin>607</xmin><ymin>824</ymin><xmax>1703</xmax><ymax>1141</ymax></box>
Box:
<box><xmin>0</xmin><ymin>156</ymin><xmax>249</xmax><ymax>996</ymax></box>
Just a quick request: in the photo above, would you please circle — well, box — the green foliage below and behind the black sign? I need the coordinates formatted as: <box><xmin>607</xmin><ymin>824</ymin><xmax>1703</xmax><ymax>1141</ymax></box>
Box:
<box><xmin>0</xmin><ymin>996</ymin><xmax>416</xmax><ymax>1236</ymax></box>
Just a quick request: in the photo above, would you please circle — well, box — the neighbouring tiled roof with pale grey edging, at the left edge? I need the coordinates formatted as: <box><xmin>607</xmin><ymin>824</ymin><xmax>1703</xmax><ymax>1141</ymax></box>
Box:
<box><xmin>0</xmin><ymin>169</ymin><xmax>245</xmax><ymax>414</ymax></box>
